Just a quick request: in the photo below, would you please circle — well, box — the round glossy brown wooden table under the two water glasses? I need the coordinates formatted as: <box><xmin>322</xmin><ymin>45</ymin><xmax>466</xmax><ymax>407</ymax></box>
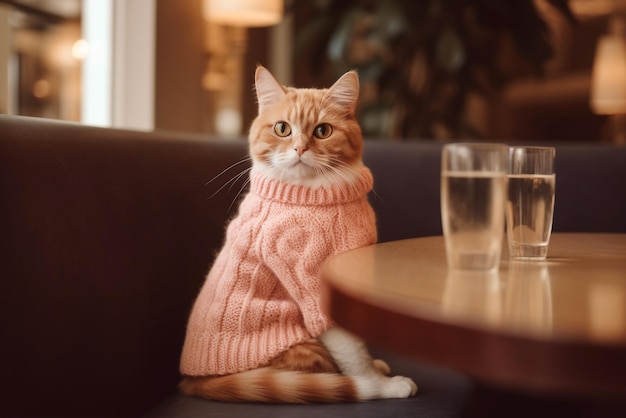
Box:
<box><xmin>322</xmin><ymin>234</ymin><xmax>626</xmax><ymax>398</ymax></box>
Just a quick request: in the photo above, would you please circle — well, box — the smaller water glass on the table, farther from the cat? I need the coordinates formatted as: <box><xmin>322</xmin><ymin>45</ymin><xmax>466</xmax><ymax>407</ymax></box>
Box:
<box><xmin>506</xmin><ymin>147</ymin><xmax>556</xmax><ymax>260</ymax></box>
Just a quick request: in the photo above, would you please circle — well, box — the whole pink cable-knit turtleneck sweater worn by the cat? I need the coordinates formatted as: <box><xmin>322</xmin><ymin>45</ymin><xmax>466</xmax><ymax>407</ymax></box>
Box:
<box><xmin>180</xmin><ymin>168</ymin><xmax>376</xmax><ymax>376</ymax></box>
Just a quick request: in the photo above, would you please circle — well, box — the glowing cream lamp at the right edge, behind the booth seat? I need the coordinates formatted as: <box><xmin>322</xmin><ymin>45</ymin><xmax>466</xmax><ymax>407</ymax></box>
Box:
<box><xmin>591</xmin><ymin>16</ymin><xmax>626</xmax><ymax>143</ymax></box>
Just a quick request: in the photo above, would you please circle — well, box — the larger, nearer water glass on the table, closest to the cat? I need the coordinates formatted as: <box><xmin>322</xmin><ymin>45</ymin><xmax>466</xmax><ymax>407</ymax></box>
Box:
<box><xmin>441</xmin><ymin>143</ymin><xmax>508</xmax><ymax>270</ymax></box>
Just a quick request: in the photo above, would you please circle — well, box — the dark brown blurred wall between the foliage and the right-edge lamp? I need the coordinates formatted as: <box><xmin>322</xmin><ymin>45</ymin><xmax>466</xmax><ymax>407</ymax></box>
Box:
<box><xmin>487</xmin><ymin>2</ymin><xmax>611</xmax><ymax>142</ymax></box>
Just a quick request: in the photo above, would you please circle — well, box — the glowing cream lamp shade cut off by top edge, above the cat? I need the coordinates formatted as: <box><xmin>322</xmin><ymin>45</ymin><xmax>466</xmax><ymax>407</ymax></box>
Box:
<box><xmin>204</xmin><ymin>0</ymin><xmax>283</xmax><ymax>27</ymax></box>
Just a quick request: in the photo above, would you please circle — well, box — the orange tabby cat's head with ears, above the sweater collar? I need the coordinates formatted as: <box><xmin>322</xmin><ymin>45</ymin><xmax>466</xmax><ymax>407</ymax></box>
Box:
<box><xmin>249</xmin><ymin>67</ymin><xmax>363</xmax><ymax>187</ymax></box>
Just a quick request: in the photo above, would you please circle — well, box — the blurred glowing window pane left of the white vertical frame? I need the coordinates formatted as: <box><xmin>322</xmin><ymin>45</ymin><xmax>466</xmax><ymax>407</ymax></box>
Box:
<box><xmin>0</xmin><ymin>2</ymin><xmax>81</xmax><ymax>121</ymax></box>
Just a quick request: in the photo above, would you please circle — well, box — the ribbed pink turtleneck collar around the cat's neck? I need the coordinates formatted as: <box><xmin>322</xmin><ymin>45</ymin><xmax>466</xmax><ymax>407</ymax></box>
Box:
<box><xmin>250</xmin><ymin>167</ymin><xmax>374</xmax><ymax>206</ymax></box>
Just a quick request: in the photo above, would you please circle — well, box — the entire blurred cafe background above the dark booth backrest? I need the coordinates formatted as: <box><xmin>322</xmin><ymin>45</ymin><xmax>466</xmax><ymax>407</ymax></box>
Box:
<box><xmin>0</xmin><ymin>0</ymin><xmax>626</xmax><ymax>142</ymax></box>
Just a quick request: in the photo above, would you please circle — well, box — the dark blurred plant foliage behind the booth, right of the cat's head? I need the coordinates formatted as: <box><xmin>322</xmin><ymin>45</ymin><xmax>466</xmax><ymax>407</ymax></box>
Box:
<box><xmin>293</xmin><ymin>0</ymin><xmax>575</xmax><ymax>139</ymax></box>
